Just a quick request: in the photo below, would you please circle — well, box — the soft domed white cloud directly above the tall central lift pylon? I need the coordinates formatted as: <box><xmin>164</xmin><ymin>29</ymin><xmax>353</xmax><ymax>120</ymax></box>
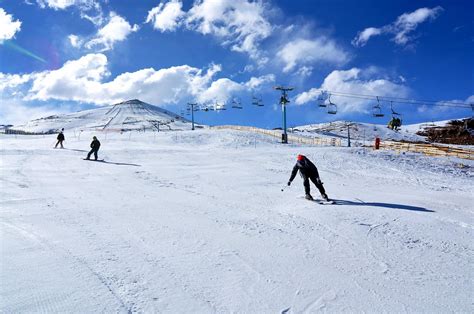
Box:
<box><xmin>277</xmin><ymin>37</ymin><xmax>349</xmax><ymax>73</ymax></box>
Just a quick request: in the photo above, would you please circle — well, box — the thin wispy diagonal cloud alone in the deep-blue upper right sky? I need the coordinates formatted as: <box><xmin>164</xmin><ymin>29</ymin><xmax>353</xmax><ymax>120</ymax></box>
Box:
<box><xmin>352</xmin><ymin>6</ymin><xmax>443</xmax><ymax>47</ymax></box>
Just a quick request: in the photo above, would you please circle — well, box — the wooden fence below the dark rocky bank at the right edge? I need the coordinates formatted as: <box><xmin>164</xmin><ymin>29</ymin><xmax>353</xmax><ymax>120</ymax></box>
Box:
<box><xmin>380</xmin><ymin>141</ymin><xmax>474</xmax><ymax>160</ymax></box>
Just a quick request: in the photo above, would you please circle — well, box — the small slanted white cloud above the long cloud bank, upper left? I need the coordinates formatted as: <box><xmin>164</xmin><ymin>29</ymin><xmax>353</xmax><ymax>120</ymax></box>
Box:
<box><xmin>84</xmin><ymin>12</ymin><xmax>139</xmax><ymax>51</ymax></box>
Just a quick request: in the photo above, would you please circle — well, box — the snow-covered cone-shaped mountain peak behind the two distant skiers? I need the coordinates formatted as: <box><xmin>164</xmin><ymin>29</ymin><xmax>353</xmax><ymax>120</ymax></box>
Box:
<box><xmin>13</xmin><ymin>99</ymin><xmax>191</xmax><ymax>133</ymax></box>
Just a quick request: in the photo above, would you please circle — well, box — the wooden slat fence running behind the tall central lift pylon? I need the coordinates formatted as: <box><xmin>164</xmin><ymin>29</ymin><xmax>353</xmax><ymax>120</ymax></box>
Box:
<box><xmin>212</xmin><ymin>125</ymin><xmax>341</xmax><ymax>146</ymax></box>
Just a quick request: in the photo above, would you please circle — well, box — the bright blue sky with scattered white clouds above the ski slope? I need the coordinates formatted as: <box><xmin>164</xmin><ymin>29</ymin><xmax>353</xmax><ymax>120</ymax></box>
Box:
<box><xmin>0</xmin><ymin>0</ymin><xmax>474</xmax><ymax>128</ymax></box>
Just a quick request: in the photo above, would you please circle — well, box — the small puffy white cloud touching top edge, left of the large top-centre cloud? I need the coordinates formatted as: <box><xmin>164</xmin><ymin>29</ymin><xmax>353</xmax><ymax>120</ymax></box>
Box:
<box><xmin>145</xmin><ymin>0</ymin><xmax>185</xmax><ymax>32</ymax></box>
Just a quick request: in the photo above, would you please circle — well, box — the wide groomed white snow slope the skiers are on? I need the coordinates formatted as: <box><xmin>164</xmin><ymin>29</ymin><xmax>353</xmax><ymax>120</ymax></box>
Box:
<box><xmin>0</xmin><ymin>129</ymin><xmax>474</xmax><ymax>313</ymax></box>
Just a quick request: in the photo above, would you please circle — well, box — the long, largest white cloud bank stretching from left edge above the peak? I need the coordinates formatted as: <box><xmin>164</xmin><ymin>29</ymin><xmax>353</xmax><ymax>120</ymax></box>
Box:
<box><xmin>0</xmin><ymin>53</ymin><xmax>274</xmax><ymax>106</ymax></box>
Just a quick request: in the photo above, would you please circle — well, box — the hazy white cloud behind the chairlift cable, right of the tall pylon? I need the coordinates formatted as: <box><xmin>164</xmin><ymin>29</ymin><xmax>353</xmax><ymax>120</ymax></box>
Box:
<box><xmin>295</xmin><ymin>68</ymin><xmax>410</xmax><ymax>113</ymax></box>
